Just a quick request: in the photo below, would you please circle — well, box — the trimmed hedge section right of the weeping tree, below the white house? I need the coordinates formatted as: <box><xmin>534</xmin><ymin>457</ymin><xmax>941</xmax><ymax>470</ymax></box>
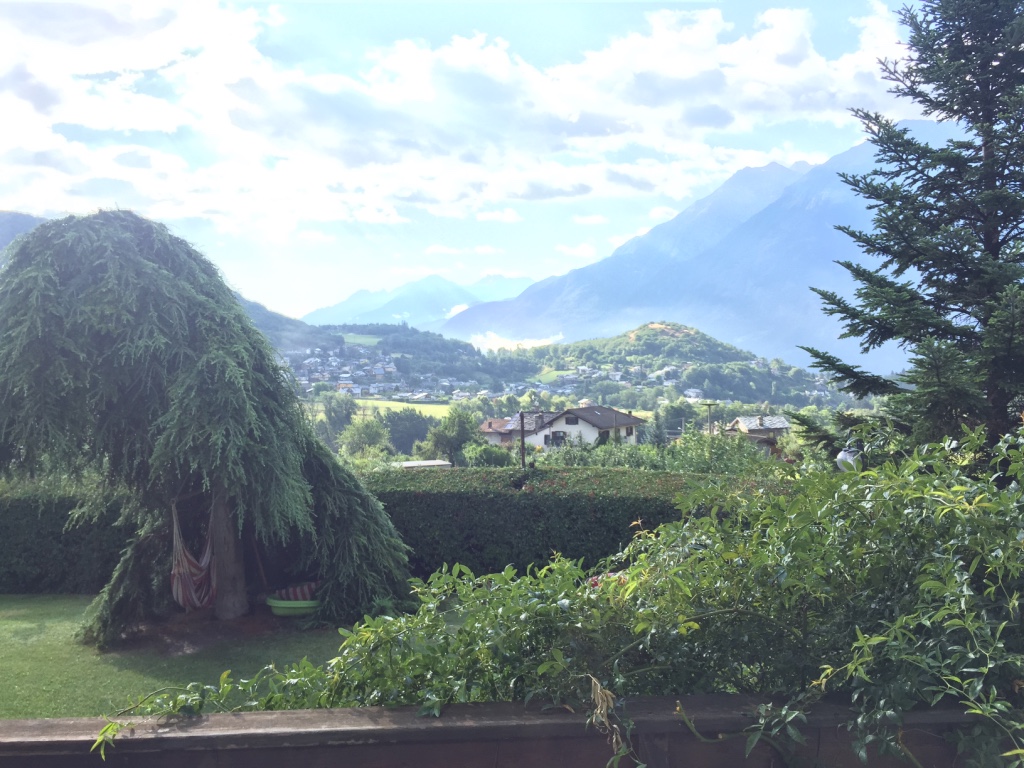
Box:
<box><xmin>361</xmin><ymin>467</ymin><xmax>703</xmax><ymax>579</ymax></box>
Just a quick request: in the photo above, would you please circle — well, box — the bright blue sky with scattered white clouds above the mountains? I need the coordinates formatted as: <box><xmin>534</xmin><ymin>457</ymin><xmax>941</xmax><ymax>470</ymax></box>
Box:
<box><xmin>0</xmin><ymin>0</ymin><xmax>916</xmax><ymax>317</ymax></box>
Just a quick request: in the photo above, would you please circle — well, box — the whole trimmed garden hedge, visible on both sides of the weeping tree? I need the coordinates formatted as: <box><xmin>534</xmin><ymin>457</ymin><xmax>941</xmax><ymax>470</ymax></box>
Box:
<box><xmin>0</xmin><ymin>467</ymin><xmax>702</xmax><ymax>594</ymax></box>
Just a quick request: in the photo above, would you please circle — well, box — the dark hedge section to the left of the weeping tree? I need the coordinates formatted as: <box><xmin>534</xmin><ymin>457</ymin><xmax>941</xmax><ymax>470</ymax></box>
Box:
<box><xmin>0</xmin><ymin>484</ymin><xmax>127</xmax><ymax>594</ymax></box>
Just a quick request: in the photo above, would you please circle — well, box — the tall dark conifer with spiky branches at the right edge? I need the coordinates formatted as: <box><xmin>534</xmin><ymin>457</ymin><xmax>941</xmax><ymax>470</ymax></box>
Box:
<box><xmin>807</xmin><ymin>0</ymin><xmax>1024</xmax><ymax>441</ymax></box>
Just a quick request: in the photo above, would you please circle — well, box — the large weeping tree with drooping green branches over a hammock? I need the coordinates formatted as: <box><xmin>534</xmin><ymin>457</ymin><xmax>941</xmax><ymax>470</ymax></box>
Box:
<box><xmin>0</xmin><ymin>211</ymin><xmax>407</xmax><ymax>643</ymax></box>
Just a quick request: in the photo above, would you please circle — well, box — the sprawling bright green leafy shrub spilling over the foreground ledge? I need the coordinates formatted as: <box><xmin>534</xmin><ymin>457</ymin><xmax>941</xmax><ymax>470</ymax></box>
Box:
<box><xmin>106</xmin><ymin>430</ymin><xmax>1024</xmax><ymax>768</ymax></box>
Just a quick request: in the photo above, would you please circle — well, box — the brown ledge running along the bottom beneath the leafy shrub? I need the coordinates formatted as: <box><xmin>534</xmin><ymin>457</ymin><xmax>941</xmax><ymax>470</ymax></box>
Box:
<box><xmin>0</xmin><ymin>695</ymin><xmax>968</xmax><ymax>768</ymax></box>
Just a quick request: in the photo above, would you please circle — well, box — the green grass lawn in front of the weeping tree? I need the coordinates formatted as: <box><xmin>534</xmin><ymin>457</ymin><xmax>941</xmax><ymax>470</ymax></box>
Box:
<box><xmin>0</xmin><ymin>595</ymin><xmax>341</xmax><ymax>718</ymax></box>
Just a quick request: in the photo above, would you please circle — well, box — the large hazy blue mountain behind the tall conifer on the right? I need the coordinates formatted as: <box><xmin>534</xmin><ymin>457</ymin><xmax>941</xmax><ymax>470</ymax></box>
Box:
<box><xmin>440</xmin><ymin>123</ymin><xmax>956</xmax><ymax>374</ymax></box>
